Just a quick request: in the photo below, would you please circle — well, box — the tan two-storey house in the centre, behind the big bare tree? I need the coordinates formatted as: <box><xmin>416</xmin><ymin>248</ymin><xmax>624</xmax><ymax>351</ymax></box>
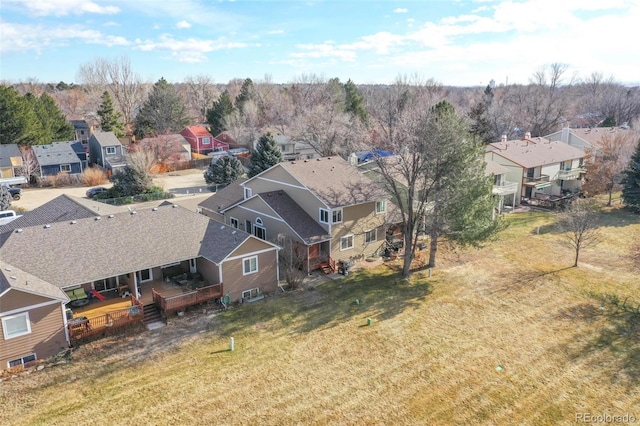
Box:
<box><xmin>200</xmin><ymin>157</ymin><xmax>386</xmax><ymax>270</ymax></box>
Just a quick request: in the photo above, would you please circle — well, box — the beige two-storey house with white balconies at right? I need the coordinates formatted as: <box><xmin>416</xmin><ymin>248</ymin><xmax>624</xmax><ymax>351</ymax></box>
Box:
<box><xmin>485</xmin><ymin>132</ymin><xmax>585</xmax><ymax>205</ymax></box>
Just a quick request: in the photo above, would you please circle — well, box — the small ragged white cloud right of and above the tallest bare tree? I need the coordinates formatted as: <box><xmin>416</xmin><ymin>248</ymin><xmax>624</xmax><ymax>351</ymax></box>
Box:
<box><xmin>134</xmin><ymin>34</ymin><xmax>247</xmax><ymax>63</ymax></box>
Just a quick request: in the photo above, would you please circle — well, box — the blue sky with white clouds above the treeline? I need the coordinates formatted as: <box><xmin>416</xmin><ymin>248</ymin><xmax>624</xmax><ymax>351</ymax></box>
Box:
<box><xmin>0</xmin><ymin>0</ymin><xmax>640</xmax><ymax>86</ymax></box>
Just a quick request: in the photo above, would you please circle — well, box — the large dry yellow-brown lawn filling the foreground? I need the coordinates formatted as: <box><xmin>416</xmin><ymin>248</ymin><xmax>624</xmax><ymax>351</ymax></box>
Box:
<box><xmin>0</xmin><ymin>205</ymin><xmax>640</xmax><ymax>425</ymax></box>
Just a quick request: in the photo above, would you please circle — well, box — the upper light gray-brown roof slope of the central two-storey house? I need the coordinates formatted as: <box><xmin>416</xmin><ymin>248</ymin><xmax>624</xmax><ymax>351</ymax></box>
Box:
<box><xmin>278</xmin><ymin>157</ymin><xmax>387</xmax><ymax>207</ymax></box>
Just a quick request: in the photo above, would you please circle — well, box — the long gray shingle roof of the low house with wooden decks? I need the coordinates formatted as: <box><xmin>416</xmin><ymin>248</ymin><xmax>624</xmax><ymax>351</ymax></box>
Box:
<box><xmin>0</xmin><ymin>206</ymin><xmax>256</xmax><ymax>287</ymax></box>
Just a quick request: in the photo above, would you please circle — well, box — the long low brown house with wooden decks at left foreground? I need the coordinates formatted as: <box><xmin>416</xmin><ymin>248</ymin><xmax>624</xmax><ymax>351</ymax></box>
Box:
<box><xmin>0</xmin><ymin>205</ymin><xmax>279</xmax><ymax>368</ymax></box>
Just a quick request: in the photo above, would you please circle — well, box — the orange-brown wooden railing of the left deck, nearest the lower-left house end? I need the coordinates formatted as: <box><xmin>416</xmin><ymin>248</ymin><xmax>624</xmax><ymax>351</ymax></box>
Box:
<box><xmin>67</xmin><ymin>296</ymin><xmax>144</xmax><ymax>342</ymax></box>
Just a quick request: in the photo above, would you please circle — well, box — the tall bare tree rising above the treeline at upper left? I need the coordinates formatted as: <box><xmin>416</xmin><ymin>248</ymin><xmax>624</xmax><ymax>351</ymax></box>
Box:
<box><xmin>77</xmin><ymin>56</ymin><xmax>146</xmax><ymax>130</ymax></box>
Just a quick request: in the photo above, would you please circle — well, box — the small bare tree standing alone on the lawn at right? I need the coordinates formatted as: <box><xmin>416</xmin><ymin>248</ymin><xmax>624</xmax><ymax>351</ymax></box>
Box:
<box><xmin>558</xmin><ymin>199</ymin><xmax>601</xmax><ymax>267</ymax></box>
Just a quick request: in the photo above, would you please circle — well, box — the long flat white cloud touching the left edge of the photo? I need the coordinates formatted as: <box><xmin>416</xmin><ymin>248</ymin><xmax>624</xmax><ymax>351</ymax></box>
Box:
<box><xmin>0</xmin><ymin>22</ymin><xmax>130</xmax><ymax>53</ymax></box>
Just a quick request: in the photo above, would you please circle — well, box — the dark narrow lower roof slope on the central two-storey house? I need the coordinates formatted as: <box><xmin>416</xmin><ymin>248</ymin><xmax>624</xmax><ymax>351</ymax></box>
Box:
<box><xmin>259</xmin><ymin>191</ymin><xmax>331</xmax><ymax>244</ymax></box>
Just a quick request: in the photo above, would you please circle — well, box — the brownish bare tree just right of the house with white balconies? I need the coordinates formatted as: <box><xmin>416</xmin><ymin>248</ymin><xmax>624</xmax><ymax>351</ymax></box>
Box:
<box><xmin>582</xmin><ymin>130</ymin><xmax>640</xmax><ymax>206</ymax></box>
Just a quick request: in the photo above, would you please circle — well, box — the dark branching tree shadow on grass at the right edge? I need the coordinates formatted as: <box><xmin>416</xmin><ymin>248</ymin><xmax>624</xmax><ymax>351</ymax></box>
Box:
<box><xmin>559</xmin><ymin>294</ymin><xmax>640</xmax><ymax>388</ymax></box>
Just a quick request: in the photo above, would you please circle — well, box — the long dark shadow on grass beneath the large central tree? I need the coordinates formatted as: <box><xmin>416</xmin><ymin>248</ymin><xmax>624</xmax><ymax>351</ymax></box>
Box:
<box><xmin>210</xmin><ymin>267</ymin><xmax>431</xmax><ymax>336</ymax></box>
